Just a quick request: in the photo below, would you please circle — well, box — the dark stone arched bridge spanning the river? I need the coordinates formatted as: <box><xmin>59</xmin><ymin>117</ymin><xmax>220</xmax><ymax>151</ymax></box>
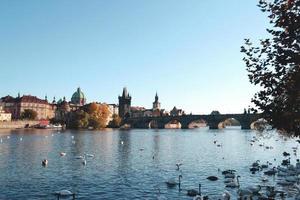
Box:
<box><xmin>124</xmin><ymin>113</ymin><xmax>262</xmax><ymax>129</ymax></box>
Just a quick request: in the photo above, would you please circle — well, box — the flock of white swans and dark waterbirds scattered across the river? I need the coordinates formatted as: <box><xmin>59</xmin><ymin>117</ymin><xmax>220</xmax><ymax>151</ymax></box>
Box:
<box><xmin>0</xmin><ymin>130</ymin><xmax>300</xmax><ymax>200</ymax></box>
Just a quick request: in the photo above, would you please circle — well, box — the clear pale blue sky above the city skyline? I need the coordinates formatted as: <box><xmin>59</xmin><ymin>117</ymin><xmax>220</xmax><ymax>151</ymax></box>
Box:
<box><xmin>0</xmin><ymin>0</ymin><xmax>267</xmax><ymax>113</ymax></box>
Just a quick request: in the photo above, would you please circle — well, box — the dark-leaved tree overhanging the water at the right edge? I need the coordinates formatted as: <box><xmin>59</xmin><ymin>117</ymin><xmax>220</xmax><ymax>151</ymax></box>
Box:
<box><xmin>241</xmin><ymin>0</ymin><xmax>300</xmax><ymax>135</ymax></box>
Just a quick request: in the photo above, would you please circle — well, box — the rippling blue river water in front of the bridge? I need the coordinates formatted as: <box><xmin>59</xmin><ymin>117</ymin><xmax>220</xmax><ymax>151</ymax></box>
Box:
<box><xmin>0</xmin><ymin>128</ymin><xmax>298</xmax><ymax>200</ymax></box>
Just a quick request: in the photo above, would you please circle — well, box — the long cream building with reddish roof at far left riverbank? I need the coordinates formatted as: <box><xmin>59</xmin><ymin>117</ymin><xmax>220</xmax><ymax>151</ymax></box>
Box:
<box><xmin>0</xmin><ymin>95</ymin><xmax>55</xmax><ymax>120</ymax></box>
